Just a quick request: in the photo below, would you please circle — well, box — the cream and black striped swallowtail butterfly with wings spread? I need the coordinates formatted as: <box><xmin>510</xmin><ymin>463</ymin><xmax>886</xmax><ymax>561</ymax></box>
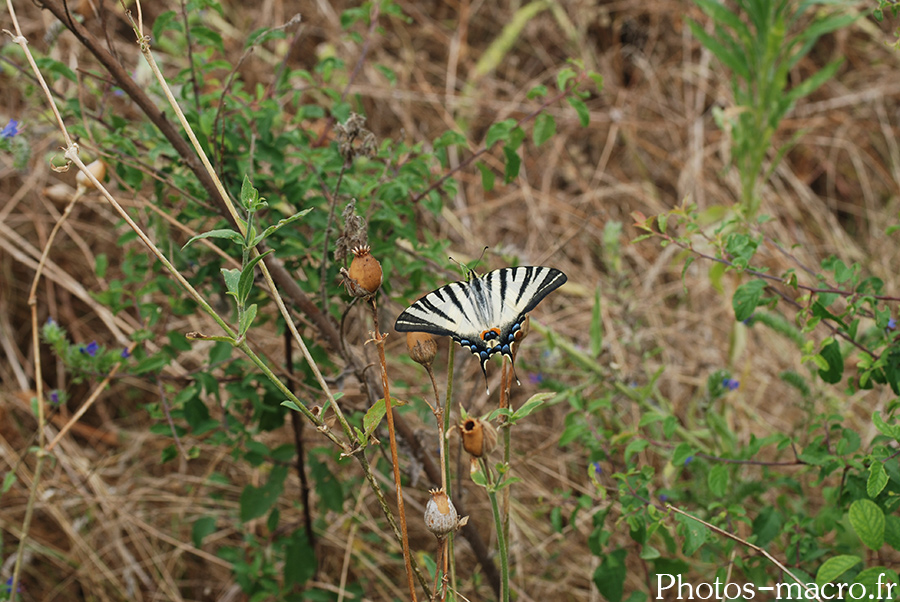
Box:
<box><xmin>394</xmin><ymin>266</ymin><xmax>566</xmax><ymax>381</ymax></box>
